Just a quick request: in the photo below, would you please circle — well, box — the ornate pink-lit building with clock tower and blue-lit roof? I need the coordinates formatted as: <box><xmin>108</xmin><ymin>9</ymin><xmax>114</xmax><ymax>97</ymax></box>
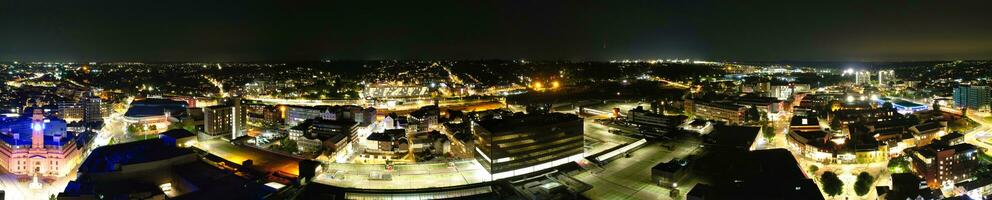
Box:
<box><xmin>0</xmin><ymin>109</ymin><xmax>90</xmax><ymax>176</ymax></box>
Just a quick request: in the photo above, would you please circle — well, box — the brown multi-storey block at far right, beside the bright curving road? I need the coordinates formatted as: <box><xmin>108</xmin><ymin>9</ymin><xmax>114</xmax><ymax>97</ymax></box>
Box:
<box><xmin>910</xmin><ymin>142</ymin><xmax>981</xmax><ymax>189</ymax></box>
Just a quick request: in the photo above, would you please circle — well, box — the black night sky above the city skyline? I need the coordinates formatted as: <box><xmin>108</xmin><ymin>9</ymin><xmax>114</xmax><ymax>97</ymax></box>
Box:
<box><xmin>0</xmin><ymin>0</ymin><xmax>992</xmax><ymax>62</ymax></box>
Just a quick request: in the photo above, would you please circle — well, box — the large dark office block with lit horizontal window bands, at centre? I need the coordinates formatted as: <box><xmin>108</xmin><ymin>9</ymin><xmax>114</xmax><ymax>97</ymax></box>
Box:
<box><xmin>472</xmin><ymin>113</ymin><xmax>584</xmax><ymax>180</ymax></box>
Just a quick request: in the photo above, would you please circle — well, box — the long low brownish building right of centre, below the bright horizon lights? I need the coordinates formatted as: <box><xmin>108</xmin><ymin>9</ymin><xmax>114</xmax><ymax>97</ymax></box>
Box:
<box><xmin>685</xmin><ymin>100</ymin><xmax>747</xmax><ymax>124</ymax></box>
